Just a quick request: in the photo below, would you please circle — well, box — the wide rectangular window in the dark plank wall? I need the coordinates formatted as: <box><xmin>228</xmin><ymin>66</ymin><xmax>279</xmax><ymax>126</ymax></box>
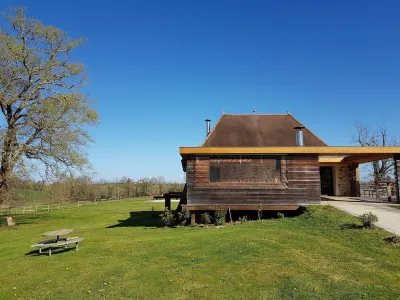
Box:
<box><xmin>210</xmin><ymin>158</ymin><xmax>281</xmax><ymax>183</ymax></box>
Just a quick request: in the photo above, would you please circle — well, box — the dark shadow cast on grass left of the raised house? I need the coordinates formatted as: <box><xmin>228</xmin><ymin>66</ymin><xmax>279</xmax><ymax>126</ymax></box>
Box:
<box><xmin>107</xmin><ymin>211</ymin><xmax>164</xmax><ymax>228</ymax></box>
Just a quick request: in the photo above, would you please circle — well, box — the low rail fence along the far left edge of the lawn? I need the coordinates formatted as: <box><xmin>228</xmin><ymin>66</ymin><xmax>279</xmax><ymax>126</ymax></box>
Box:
<box><xmin>0</xmin><ymin>199</ymin><xmax>126</xmax><ymax>216</ymax></box>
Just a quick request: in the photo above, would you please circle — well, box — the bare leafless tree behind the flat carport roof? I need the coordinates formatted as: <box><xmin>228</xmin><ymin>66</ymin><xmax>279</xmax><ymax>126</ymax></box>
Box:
<box><xmin>351</xmin><ymin>124</ymin><xmax>399</xmax><ymax>182</ymax></box>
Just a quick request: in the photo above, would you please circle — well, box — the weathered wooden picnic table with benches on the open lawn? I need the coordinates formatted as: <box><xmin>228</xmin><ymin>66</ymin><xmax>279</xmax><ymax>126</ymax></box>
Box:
<box><xmin>31</xmin><ymin>229</ymin><xmax>83</xmax><ymax>256</ymax></box>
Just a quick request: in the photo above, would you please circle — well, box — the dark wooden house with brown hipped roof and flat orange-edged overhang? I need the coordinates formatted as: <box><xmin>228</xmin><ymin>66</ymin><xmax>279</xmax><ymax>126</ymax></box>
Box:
<box><xmin>180</xmin><ymin>114</ymin><xmax>400</xmax><ymax>223</ymax></box>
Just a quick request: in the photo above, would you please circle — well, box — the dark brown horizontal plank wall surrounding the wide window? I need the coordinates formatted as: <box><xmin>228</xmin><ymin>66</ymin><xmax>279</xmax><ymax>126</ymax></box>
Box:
<box><xmin>186</xmin><ymin>156</ymin><xmax>321</xmax><ymax>209</ymax></box>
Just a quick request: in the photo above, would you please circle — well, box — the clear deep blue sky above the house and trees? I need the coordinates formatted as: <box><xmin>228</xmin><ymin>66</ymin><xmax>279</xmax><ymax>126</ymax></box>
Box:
<box><xmin>0</xmin><ymin>0</ymin><xmax>400</xmax><ymax>181</ymax></box>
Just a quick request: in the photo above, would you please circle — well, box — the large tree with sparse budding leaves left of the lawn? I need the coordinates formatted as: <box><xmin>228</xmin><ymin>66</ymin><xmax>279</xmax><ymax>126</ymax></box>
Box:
<box><xmin>0</xmin><ymin>8</ymin><xmax>98</xmax><ymax>201</ymax></box>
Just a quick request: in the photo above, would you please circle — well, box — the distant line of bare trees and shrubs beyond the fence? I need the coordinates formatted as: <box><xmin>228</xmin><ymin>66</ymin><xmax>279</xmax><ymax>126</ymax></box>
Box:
<box><xmin>3</xmin><ymin>176</ymin><xmax>184</xmax><ymax>204</ymax></box>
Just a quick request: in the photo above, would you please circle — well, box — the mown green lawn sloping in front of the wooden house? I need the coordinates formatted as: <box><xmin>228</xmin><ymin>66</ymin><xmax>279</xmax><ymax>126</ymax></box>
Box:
<box><xmin>0</xmin><ymin>199</ymin><xmax>400</xmax><ymax>300</ymax></box>
